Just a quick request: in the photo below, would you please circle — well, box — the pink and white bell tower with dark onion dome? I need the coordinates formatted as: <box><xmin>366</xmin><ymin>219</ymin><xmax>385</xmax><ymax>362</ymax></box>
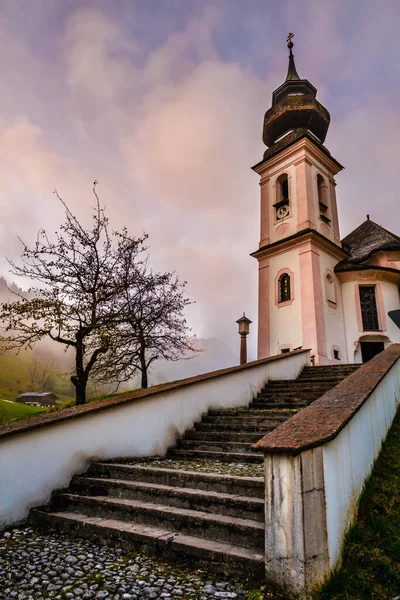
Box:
<box><xmin>252</xmin><ymin>34</ymin><xmax>347</xmax><ymax>364</ymax></box>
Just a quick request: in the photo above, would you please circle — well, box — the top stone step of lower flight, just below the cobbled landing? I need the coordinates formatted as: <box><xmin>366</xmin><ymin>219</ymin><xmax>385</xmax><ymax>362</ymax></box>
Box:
<box><xmin>87</xmin><ymin>462</ymin><xmax>264</xmax><ymax>498</ymax></box>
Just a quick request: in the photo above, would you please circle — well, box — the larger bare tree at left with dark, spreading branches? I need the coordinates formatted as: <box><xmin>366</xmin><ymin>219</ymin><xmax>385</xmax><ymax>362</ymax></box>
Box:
<box><xmin>0</xmin><ymin>182</ymin><xmax>147</xmax><ymax>404</ymax></box>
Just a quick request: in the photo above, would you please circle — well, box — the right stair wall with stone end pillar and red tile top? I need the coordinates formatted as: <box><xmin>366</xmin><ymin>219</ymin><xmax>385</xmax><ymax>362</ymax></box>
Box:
<box><xmin>252</xmin><ymin>344</ymin><xmax>400</xmax><ymax>598</ymax></box>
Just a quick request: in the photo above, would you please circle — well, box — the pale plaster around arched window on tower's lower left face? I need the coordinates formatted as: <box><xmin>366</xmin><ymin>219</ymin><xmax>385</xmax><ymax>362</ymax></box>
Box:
<box><xmin>269</xmin><ymin>249</ymin><xmax>303</xmax><ymax>355</ymax></box>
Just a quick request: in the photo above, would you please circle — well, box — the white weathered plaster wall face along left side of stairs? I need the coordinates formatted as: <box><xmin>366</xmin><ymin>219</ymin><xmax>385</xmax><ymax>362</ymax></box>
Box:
<box><xmin>0</xmin><ymin>352</ymin><xmax>309</xmax><ymax>530</ymax></box>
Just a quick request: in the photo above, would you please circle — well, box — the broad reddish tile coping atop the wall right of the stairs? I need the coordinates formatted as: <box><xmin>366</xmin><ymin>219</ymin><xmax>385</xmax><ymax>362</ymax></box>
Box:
<box><xmin>251</xmin><ymin>344</ymin><xmax>400</xmax><ymax>455</ymax></box>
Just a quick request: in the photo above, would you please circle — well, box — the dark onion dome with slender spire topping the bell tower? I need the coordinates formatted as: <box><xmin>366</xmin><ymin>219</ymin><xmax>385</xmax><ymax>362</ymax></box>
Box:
<box><xmin>263</xmin><ymin>33</ymin><xmax>331</xmax><ymax>146</ymax></box>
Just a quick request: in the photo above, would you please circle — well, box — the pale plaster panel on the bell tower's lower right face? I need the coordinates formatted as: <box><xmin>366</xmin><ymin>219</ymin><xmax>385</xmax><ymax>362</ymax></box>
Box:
<box><xmin>320</xmin><ymin>251</ymin><xmax>348</xmax><ymax>364</ymax></box>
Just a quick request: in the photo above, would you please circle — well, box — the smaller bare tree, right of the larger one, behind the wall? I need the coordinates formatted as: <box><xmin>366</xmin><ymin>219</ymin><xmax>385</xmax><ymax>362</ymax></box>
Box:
<box><xmin>95</xmin><ymin>259</ymin><xmax>198</xmax><ymax>388</ymax></box>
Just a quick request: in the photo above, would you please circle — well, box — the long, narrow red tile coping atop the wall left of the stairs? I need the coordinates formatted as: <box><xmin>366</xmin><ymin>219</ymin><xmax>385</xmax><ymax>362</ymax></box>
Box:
<box><xmin>0</xmin><ymin>349</ymin><xmax>309</xmax><ymax>439</ymax></box>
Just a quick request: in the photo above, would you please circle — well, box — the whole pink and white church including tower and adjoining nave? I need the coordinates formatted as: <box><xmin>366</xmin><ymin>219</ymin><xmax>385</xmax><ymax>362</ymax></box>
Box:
<box><xmin>251</xmin><ymin>34</ymin><xmax>400</xmax><ymax>365</ymax></box>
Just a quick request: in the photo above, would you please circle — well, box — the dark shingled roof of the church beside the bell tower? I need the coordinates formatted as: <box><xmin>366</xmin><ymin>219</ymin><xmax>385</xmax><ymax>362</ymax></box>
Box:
<box><xmin>335</xmin><ymin>219</ymin><xmax>400</xmax><ymax>272</ymax></box>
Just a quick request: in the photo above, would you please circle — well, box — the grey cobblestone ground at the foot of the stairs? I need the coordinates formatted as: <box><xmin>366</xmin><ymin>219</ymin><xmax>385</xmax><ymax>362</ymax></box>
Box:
<box><xmin>0</xmin><ymin>527</ymin><xmax>275</xmax><ymax>600</ymax></box>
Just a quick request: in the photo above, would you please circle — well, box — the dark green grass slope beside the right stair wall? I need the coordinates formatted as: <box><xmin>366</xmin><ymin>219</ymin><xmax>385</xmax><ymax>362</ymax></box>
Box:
<box><xmin>315</xmin><ymin>413</ymin><xmax>400</xmax><ymax>600</ymax></box>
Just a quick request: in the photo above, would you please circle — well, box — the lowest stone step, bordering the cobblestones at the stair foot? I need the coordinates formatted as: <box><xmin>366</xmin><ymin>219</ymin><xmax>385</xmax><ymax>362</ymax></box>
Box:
<box><xmin>31</xmin><ymin>509</ymin><xmax>265</xmax><ymax>578</ymax></box>
